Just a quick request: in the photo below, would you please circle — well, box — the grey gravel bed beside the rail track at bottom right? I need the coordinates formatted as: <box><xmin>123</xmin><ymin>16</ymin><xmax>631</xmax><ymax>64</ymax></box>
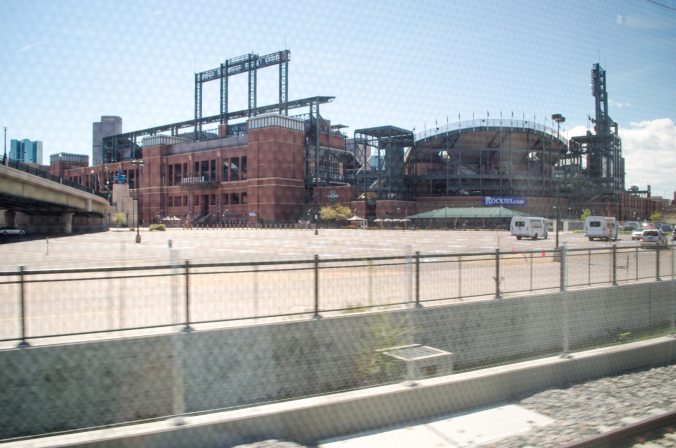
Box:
<box><xmin>490</xmin><ymin>365</ymin><xmax>676</xmax><ymax>448</ymax></box>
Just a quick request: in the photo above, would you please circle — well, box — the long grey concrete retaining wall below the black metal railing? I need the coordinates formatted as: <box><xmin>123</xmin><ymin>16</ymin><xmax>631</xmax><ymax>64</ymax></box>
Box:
<box><xmin>0</xmin><ymin>282</ymin><xmax>676</xmax><ymax>438</ymax></box>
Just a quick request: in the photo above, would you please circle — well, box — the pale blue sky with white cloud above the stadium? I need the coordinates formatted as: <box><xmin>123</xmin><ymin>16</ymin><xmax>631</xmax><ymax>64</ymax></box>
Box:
<box><xmin>0</xmin><ymin>0</ymin><xmax>676</xmax><ymax>197</ymax></box>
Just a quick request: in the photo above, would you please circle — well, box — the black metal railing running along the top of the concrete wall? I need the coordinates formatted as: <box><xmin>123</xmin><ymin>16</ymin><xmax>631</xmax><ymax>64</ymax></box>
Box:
<box><xmin>0</xmin><ymin>245</ymin><xmax>676</xmax><ymax>346</ymax></box>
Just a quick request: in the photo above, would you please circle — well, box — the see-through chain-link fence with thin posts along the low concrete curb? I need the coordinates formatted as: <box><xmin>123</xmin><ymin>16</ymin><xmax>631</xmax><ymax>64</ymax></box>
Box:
<box><xmin>0</xmin><ymin>242</ymin><xmax>676</xmax><ymax>439</ymax></box>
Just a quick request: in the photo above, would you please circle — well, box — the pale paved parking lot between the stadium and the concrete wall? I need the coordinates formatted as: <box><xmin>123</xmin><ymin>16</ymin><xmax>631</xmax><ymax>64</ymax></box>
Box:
<box><xmin>0</xmin><ymin>229</ymin><xmax>674</xmax><ymax>346</ymax></box>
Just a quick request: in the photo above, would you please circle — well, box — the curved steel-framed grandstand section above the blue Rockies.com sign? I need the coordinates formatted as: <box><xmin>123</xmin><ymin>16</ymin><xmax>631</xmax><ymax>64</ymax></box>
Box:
<box><xmin>406</xmin><ymin>118</ymin><xmax>568</xmax><ymax>197</ymax></box>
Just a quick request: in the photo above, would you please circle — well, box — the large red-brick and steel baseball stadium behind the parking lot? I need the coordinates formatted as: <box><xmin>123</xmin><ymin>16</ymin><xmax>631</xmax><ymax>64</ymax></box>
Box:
<box><xmin>62</xmin><ymin>50</ymin><xmax>661</xmax><ymax>225</ymax></box>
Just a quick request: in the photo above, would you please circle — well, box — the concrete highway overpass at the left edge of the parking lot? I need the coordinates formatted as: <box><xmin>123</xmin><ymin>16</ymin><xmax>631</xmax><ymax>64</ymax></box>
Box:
<box><xmin>0</xmin><ymin>165</ymin><xmax>109</xmax><ymax>233</ymax></box>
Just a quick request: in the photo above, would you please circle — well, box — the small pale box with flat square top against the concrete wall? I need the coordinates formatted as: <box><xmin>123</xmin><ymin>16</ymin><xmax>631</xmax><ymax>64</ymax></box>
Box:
<box><xmin>376</xmin><ymin>344</ymin><xmax>453</xmax><ymax>386</ymax></box>
